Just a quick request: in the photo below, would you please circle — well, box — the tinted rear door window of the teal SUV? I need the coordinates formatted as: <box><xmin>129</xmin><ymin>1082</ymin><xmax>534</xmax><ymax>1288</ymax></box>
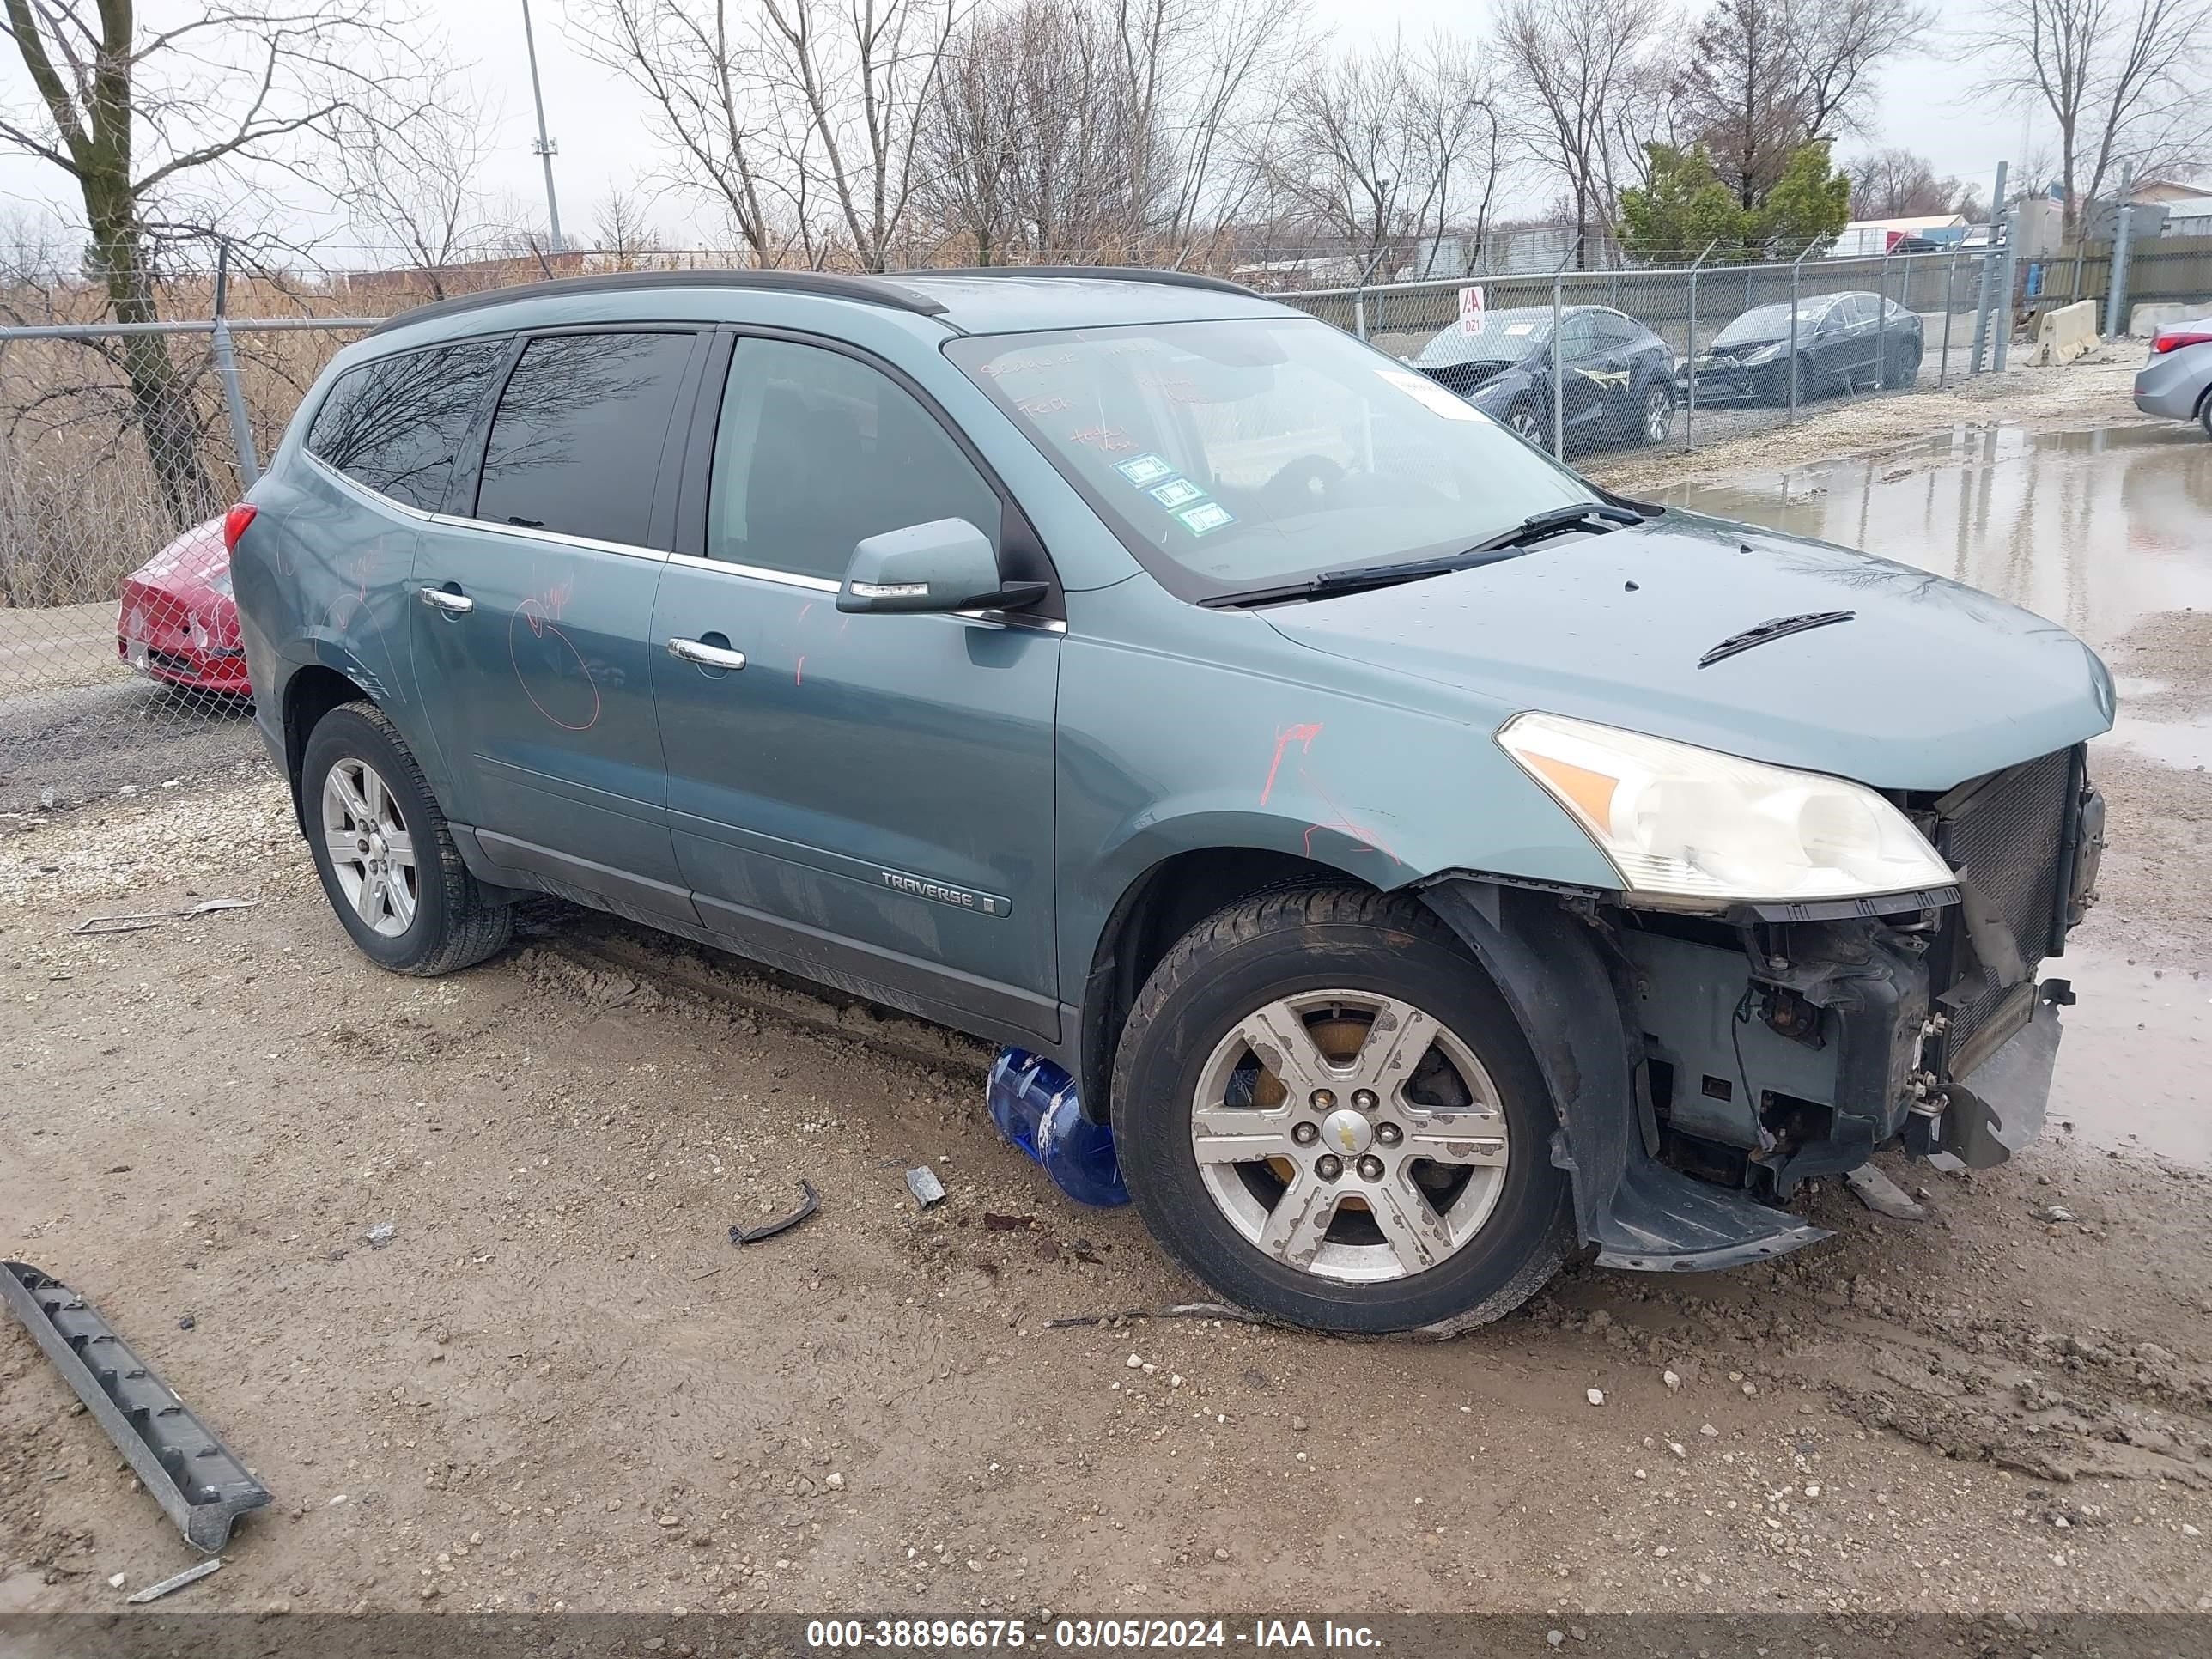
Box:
<box><xmin>476</xmin><ymin>334</ymin><xmax>695</xmax><ymax>546</ymax></box>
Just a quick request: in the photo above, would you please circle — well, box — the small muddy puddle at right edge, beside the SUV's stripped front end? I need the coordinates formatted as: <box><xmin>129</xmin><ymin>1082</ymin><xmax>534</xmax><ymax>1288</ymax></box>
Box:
<box><xmin>2042</xmin><ymin>945</ymin><xmax>2212</xmax><ymax>1166</ymax></box>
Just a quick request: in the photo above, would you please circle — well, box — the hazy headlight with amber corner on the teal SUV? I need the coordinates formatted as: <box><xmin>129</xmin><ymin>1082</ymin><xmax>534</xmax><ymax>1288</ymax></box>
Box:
<box><xmin>1498</xmin><ymin>714</ymin><xmax>1954</xmax><ymax>902</ymax></box>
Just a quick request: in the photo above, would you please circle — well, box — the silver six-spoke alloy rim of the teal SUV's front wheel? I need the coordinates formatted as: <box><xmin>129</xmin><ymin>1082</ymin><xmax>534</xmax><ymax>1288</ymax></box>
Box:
<box><xmin>1190</xmin><ymin>991</ymin><xmax>1509</xmax><ymax>1283</ymax></box>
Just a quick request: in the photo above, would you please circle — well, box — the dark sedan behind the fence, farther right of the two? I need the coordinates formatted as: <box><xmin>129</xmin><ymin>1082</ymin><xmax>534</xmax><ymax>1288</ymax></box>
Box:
<box><xmin>1692</xmin><ymin>295</ymin><xmax>1923</xmax><ymax>403</ymax></box>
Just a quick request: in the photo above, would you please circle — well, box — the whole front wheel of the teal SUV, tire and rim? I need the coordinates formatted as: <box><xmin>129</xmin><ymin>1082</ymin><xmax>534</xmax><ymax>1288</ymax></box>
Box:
<box><xmin>1113</xmin><ymin>887</ymin><xmax>1571</xmax><ymax>1332</ymax></box>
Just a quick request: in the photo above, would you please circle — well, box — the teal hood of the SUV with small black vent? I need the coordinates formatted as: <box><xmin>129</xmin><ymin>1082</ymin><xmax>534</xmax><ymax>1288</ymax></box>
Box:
<box><xmin>1261</xmin><ymin>514</ymin><xmax>2112</xmax><ymax>790</ymax></box>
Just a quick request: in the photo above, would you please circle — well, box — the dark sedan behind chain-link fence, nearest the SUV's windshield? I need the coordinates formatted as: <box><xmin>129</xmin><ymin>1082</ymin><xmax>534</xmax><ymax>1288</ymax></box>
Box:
<box><xmin>1409</xmin><ymin>305</ymin><xmax>1677</xmax><ymax>453</ymax></box>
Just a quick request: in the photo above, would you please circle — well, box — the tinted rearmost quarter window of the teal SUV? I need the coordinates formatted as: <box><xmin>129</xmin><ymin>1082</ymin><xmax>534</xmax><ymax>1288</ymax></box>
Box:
<box><xmin>307</xmin><ymin>341</ymin><xmax>507</xmax><ymax>514</ymax></box>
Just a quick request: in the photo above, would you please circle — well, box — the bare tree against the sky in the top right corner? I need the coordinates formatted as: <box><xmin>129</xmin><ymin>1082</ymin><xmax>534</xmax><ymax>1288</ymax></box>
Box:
<box><xmin>1962</xmin><ymin>0</ymin><xmax>2212</xmax><ymax>234</ymax></box>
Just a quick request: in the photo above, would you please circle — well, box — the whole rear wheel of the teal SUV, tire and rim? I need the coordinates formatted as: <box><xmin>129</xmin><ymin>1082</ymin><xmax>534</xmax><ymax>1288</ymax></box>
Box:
<box><xmin>301</xmin><ymin>702</ymin><xmax>514</xmax><ymax>975</ymax></box>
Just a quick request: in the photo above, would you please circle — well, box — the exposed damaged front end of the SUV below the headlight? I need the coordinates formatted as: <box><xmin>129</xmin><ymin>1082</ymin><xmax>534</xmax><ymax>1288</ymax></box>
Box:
<box><xmin>1429</xmin><ymin>745</ymin><xmax>2104</xmax><ymax>1270</ymax></box>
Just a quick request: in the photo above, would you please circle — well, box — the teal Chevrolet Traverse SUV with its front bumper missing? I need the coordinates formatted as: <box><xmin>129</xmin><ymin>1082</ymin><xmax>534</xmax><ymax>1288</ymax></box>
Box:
<box><xmin>226</xmin><ymin>270</ymin><xmax>2112</xmax><ymax>1332</ymax></box>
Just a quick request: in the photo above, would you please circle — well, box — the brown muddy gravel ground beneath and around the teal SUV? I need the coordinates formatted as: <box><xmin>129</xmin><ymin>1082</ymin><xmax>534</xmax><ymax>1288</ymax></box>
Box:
<box><xmin>0</xmin><ymin>369</ymin><xmax>2212</xmax><ymax>1617</ymax></box>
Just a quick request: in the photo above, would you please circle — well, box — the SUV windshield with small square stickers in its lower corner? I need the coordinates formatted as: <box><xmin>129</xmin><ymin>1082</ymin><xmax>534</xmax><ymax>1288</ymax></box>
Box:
<box><xmin>945</xmin><ymin>319</ymin><xmax>1601</xmax><ymax>602</ymax></box>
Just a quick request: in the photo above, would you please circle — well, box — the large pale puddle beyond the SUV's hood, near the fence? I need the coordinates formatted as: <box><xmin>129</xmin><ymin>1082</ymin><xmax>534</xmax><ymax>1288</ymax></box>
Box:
<box><xmin>1663</xmin><ymin>422</ymin><xmax>2212</xmax><ymax>650</ymax></box>
